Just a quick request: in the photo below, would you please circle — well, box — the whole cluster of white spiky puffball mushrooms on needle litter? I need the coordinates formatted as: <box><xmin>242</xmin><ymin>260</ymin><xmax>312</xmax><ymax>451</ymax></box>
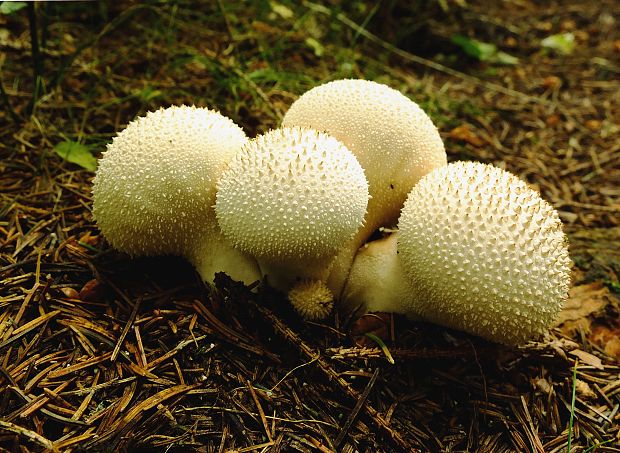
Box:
<box><xmin>93</xmin><ymin>80</ymin><xmax>570</xmax><ymax>345</ymax></box>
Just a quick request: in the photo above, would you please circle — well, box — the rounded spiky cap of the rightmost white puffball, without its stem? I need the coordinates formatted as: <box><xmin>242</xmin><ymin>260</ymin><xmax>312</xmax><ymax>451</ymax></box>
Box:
<box><xmin>398</xmin><ymin>162</ymin><xmax>570</xmax><ymax>344</ymax></box>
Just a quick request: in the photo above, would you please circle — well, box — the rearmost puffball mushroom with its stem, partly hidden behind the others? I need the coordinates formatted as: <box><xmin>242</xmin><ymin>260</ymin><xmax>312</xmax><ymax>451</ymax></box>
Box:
<box><xmin>282</xmin><ymin>79</ymin><xmax>446</xmax><ymax>295</ymax></box>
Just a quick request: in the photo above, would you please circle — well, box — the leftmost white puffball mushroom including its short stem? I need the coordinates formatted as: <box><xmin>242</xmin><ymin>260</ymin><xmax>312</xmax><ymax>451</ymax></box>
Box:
<box><xmin>93</xmin><ymin>106</ymin><xmax>260</xmax><ymax>284</ymax></box>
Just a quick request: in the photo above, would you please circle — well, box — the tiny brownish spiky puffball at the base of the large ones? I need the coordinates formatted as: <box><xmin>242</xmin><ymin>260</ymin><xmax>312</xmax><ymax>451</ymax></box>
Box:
<box><xmin>288</xmin><ymin>279</ymin><xmax>334</xmax><ymax>321</ymax></box>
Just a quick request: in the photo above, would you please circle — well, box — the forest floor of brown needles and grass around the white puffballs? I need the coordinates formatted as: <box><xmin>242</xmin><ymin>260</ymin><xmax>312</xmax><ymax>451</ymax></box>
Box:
<box><xmin>0</xmin><ymin>0</ymin><xmax>620</xmax><ymax>452</ymax></box>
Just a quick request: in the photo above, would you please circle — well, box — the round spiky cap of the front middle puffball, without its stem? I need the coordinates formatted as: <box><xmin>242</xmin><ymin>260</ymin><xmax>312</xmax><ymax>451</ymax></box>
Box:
<box><xmin>215</xmin><ymin>128</ymin><xmax>368</xmax><ymax>261</ymax></box>
